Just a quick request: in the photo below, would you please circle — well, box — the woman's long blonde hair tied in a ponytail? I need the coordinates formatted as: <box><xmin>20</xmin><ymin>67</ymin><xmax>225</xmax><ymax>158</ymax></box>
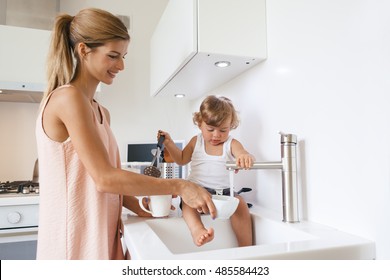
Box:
<box><xmin>42</xmin><ymin>8</ymin><xmax>130</xmax><ymax>102</ymax></box>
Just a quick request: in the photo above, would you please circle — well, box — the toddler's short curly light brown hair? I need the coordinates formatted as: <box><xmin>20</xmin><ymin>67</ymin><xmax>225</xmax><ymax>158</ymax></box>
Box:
<box><xmin>193</xmin><ymin>95</ymin><xmax>239</xmax><ymax>129</ymax></box>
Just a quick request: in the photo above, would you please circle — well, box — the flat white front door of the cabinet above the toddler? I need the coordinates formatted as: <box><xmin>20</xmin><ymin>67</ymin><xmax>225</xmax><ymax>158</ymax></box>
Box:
<box><xmin>198</xmin><ymin>0</ymin><xmax>266</xmax><ymax>57</ymax></box>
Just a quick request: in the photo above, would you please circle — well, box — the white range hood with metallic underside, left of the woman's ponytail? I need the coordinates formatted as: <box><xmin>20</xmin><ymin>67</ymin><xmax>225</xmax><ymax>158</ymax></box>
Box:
<box><xmin>0</xmin><ymin>25</ymin><xmax>51</xmax><ymax>103</ymax></box>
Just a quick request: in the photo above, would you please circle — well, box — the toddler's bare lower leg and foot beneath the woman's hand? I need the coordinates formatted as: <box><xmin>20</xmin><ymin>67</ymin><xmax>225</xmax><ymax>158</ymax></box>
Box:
<box><xmin>182</xmin><ymin>202</ymin><xmax>214</xmax><ymax>246</ymax></box>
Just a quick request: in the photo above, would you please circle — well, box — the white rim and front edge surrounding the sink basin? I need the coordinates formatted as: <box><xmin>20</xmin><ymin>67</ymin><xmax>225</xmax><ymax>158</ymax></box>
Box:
<box><xmin>122</xmin><ymin>207</ymin><xmax>375</xmax><ymax>260</ymax></box>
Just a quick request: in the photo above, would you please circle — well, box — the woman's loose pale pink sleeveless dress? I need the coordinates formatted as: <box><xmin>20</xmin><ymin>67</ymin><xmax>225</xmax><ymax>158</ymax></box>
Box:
<box><xmin>36</xmin><ymin>86</ymin><xmax>124</xmax><ymax>260</ymax></box>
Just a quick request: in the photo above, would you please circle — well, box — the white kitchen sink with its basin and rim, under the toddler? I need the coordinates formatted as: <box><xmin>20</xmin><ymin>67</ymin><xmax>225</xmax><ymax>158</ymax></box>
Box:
<box><xmin>122</xmin><ymin>207</ymin><xmax>375</xmax><ymax>260</ymax></box>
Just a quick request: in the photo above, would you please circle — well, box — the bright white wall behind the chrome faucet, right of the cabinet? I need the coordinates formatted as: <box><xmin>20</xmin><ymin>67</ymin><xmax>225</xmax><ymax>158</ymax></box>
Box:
<box><xmin>187</xmin><ymin>0</ymin><xmax>390</xmax><ymax>259</ymax></box>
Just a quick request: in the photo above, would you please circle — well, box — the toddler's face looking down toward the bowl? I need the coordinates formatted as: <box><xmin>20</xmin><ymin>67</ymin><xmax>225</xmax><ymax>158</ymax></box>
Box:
<box><xmin>199</xmin><ymin>118</ymin><xmax>231</xmax><ymax>146</ymax></box>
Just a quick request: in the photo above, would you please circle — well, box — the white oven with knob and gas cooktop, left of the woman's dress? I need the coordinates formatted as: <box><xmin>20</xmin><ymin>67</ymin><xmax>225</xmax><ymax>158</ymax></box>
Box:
<box><xmin>0</xmin><ymin>181</ymin><xmax>39</xmax><ymax>260</ymax></box>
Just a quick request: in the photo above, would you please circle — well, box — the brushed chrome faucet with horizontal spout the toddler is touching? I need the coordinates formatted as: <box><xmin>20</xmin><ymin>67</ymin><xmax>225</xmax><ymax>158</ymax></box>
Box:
<box><xmin>226</xmin><ymin>132</ymin><xmax>299</xmax><ymax>223</ymax></box>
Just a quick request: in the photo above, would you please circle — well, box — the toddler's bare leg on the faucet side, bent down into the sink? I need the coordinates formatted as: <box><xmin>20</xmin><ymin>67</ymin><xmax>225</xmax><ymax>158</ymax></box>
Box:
<box><xmin>230</xmin><ymin>195</ymin><xmax>253</xmax><ymax>247</ymax></box>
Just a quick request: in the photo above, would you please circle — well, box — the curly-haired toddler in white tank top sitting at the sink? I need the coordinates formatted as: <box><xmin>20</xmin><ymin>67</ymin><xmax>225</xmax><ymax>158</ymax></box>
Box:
<box><xmin>159</xmin><ymin>95</ymin><xmax>255</xmax><ymax>246</ymax></box>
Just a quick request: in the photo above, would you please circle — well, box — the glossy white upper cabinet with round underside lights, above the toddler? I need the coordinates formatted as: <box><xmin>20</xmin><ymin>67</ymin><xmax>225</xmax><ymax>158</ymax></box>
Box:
<box><xmin>150</xmin><ymin>0</ymin><xmax>267</xmax><ymax>99</ymax></box>
